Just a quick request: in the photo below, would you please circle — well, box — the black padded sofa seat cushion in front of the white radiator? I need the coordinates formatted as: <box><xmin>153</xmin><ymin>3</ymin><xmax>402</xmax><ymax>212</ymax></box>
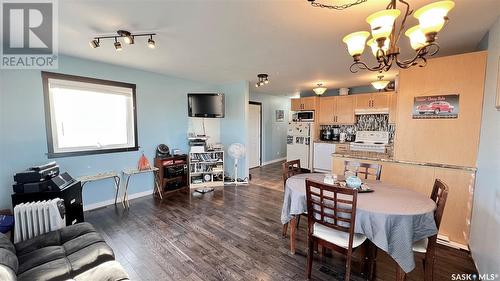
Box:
<box><xmin>15</xmin><ymin>223</ymin><xmax>118</xmax><ymax>280</ymax></box>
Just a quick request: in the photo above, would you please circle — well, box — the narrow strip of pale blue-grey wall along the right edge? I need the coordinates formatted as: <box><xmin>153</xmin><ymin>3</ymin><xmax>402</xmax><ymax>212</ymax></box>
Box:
<box><xmin>470</xmin><ymin>18</ymin><xmax>500</xmax><ymax>274</ymax></box>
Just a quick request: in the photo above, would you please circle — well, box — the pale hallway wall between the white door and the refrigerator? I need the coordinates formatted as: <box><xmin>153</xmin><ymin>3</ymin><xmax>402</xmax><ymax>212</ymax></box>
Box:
<box><xmin>250</xmin><ymin>93</ymin><xmax>290</xmax><ymax>164</ymax></box>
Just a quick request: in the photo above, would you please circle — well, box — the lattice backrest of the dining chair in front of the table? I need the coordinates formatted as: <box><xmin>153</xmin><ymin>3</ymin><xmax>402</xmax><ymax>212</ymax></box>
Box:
<box><xmin>306</xmin><ymin>179</ymin><xmax>358</xmax><ymax>238</ymax></box>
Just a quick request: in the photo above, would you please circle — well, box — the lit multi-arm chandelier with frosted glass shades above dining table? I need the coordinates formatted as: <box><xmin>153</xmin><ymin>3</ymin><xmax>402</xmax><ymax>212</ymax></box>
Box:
<box><xmin>342</xmin><ymin>0</ymin><xmax>455</xmax><ymax>73</ymax></box>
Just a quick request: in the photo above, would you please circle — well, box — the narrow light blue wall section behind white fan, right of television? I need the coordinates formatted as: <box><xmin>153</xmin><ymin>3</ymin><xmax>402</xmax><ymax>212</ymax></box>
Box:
<box><xmin>220</xmin><ymin>81</ymin><xmax>249</xmax><ymax>178</ymax></box>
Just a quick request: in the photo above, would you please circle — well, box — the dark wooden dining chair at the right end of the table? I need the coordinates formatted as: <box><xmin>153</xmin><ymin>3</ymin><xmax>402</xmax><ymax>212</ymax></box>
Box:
<box><xmin>398</xmin><ymin>179</ymin><xmax>449</xmax><ymax>281</ymax></box>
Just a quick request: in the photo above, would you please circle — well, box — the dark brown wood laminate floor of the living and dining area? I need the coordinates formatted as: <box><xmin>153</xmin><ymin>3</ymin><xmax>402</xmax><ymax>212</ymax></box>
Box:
<box><xmin>85</xmin><ymin>180</ymin><xmax>475</xmax><ymax>280</ymax></box>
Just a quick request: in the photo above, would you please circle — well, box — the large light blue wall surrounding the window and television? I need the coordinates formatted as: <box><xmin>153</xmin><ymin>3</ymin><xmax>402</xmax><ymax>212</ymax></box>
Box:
<box><xmin>0</xmin><ymin>56</ymin><xmax>248</xmax><ymax>208</ymax></box>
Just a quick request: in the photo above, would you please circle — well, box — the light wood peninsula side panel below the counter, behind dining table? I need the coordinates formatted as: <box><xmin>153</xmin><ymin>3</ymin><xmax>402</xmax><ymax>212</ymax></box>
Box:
<box><xmin>332</xmin><ymin>156</ymin><xmax>475</xmax><ymax>249</ymax></box>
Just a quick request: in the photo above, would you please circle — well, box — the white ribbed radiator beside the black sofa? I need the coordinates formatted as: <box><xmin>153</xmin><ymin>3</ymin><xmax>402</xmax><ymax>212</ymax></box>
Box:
<box><xmin>14</xmin><ymin>198</ymin><xmax>66</xmax><ymax>243</ymax></box>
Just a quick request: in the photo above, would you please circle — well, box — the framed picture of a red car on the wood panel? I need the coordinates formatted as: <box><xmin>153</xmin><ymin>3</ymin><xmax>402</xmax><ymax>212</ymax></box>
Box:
<box><xmin>413</xmin><ymin>94</ymin><xmax>460</xmax><ymax>119</ymax></box>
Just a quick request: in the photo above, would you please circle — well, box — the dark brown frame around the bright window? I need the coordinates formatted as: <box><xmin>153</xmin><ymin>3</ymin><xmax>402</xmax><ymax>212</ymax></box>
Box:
<box><xmin>41</xmin><ymin>71</ymin><xmax>140</xmax><ymax>158</ymax></box>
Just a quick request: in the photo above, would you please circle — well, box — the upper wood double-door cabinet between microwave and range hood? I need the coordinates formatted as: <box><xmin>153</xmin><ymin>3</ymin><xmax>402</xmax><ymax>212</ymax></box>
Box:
<box><xmin>318</xmin><ymin>96</ymin><xmax>355</xmax><ymax>125</ymax></box>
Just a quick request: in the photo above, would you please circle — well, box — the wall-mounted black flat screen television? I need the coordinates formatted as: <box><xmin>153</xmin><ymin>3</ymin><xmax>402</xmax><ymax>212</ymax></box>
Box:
<box><xmin>188</xmin><ymin>94</ymin><xmax>225</xmax><ymax>118</ymax></box>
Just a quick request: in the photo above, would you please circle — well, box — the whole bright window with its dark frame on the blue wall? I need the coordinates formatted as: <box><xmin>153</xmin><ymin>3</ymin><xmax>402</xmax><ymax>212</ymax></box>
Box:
<box><xmin>42</xmin><ymin>72</ymin><xmax>138</xmax><ymax>158</ymax></box>
